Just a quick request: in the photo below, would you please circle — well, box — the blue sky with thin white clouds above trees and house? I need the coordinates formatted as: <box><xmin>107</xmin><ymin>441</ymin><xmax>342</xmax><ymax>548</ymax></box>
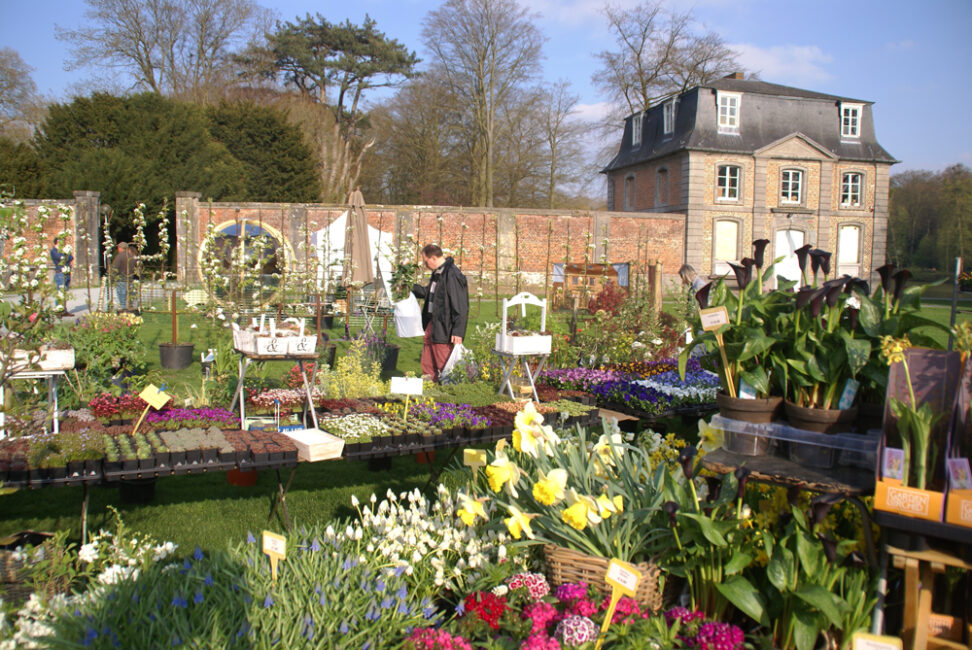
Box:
<box><xmin>0</xmin><ymin>0</ymin><xmax>972</xmax><ymax>173</ymax></box>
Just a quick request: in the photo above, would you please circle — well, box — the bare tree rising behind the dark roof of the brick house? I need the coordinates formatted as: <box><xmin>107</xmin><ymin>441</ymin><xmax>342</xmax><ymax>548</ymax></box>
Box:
<box><xmin>593</xmin><ymin>0</ymin><xmax>738</xmax><ymax>114</ymax></box>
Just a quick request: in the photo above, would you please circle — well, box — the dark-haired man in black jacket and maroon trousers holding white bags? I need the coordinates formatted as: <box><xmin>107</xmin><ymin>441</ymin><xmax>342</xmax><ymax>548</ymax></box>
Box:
<box><xmin>412</xmin><ymin>244</ymin><xmax>469</xmax><ymax>382</ymax></box>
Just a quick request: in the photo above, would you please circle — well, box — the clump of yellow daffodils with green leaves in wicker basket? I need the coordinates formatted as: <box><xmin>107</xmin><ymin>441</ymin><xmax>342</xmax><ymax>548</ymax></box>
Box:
<box><xmin>459</xmin><ymin>403</ymin><xmax>669</xmax><ymax>605</ymax></box>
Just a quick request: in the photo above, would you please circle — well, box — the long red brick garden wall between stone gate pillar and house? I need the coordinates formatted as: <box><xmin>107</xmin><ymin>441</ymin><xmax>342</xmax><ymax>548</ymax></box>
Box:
<box><xmin>175</xmin><ymin>192</ymin><xmax>685</xmax><ymax>293</ymax></box>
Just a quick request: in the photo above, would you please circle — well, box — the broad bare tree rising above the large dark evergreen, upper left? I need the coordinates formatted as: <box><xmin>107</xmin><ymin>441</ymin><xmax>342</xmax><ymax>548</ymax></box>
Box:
<box><xmin>57</xmin><ymin>0</ymin><xmax>268</xmax><ymax>101</ymax></box>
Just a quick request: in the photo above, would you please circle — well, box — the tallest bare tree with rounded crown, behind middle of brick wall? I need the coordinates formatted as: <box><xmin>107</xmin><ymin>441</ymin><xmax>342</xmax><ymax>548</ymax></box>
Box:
<box><xmin>422</xmin><ymin>0</ymin><xmax>544</xmax><ymax>207</ymax></box>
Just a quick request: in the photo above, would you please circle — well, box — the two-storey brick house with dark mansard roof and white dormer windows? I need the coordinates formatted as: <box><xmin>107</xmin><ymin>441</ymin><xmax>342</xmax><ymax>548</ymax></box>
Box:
<box><xmin>603</xmin><ymin>73</ymin><xmax>898</xmax><ymax>281</ymax></box>
